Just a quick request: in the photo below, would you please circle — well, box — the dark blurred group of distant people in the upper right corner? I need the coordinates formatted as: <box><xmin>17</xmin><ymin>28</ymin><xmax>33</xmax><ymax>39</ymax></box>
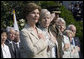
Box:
<box><xmin>68</xmin><ymin>1</ymin><xmax>83</xmax><ymax>21</ymax></box>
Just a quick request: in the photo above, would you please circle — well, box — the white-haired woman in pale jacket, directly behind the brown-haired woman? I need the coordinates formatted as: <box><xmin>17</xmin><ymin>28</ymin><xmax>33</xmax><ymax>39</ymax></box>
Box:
<box><xmin>38</xmin><ymin>9</ymin><xmax>56</xmax><ymax>58</ymax></box>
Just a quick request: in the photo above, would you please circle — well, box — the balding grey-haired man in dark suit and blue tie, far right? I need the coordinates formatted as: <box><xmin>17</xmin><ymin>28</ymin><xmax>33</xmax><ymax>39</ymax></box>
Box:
<box><xmin>67</xmin><ymin>24</ymin><xmax>80</xmax><ymax>56</ymax></box>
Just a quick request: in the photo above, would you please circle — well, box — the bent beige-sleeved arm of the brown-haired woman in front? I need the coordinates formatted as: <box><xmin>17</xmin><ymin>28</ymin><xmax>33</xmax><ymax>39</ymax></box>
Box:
<box><xmin>21</xmin><ymin>31</ymin><xmax>46</xmax><ymax>56</ymax></box>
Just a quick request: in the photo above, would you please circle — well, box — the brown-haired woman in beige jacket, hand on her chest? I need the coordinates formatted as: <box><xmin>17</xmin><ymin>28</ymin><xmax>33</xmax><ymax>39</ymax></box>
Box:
<box><xmin>20</xmin><ymin>3</ymin><xmax>48</xmax><ymax>58</ymax></box>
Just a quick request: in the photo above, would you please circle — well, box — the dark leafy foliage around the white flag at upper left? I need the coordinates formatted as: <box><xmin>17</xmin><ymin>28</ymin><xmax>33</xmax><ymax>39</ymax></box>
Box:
<box><xmin>1</xmin><ymin>1</ymin><xmax>30</xmax><ymax>28</ymax></box>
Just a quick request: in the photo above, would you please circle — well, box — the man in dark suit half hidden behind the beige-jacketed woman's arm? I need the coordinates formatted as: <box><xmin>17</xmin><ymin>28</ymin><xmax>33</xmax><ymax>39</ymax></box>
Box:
<box><xmin>14</xmin><ymin>31</ymin><xmax>20</xmax><ymax>58</ymax></box>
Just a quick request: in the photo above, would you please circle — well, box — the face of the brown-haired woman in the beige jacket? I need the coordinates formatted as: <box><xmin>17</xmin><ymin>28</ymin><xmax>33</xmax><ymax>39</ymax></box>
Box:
<box><xmin>26</xmin><ymin>9</ymin><xmax>39</xmax><ymax>23</ymax></box>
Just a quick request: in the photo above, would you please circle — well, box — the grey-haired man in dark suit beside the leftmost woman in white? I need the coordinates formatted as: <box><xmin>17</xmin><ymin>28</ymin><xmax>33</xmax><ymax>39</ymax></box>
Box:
<box><xmin>5</xmin><ymin>27</ymin><xmax>16</xmax><ymax>58</ymax></box>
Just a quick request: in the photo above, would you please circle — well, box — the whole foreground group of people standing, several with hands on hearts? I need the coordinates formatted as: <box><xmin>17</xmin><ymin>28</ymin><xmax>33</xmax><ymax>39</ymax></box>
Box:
<box><xmin>1</xmin><ymin>3</ymin><xmax>81</xmax><ymax>58</ymax></box>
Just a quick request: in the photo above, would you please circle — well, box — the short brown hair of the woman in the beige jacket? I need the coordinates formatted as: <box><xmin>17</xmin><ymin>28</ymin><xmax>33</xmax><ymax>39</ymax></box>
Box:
<box><xmin>23</xmin><ymin>3</ymin><xmax>41</xmax><ymax>19</ymax></box>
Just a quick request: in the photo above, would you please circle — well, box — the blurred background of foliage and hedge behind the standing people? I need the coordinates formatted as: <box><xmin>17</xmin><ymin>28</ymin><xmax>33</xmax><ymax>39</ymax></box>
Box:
<box><xmin>1</xmin><ymin>1</ymin><xmax>83</xmax><ymax>57</ymax></box>
